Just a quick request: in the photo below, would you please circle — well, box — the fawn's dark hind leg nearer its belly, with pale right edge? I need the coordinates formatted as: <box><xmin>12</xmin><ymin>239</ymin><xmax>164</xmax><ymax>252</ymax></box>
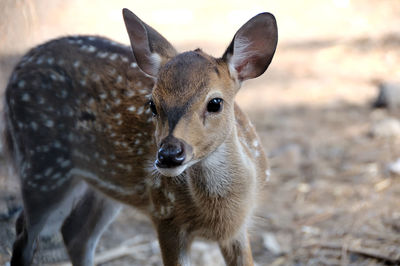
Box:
<box><xmin>61</xmin><ymin>189</ymin><xmax>122</xmax><ymax>266</ymax></box>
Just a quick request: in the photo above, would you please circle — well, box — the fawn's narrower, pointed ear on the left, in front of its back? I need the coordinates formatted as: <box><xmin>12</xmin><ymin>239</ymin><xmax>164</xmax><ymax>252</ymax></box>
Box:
<box><xmin>122</xmin><ymin>8</ymin><xmax>177</xmax><ymax>77</ymax></box>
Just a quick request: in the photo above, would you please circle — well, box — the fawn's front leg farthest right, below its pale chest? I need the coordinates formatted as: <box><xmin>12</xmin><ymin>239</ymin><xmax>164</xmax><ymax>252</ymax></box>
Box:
<box><xmin>219</xmin><ymin>230</ymin><xmax>254</xmax><ymax>266</ymax></box>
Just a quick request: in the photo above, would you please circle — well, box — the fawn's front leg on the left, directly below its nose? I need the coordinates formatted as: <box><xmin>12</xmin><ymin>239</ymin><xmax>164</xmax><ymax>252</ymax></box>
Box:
<box><xmin>156</xmin><ymin>220</ymin><xmax>192</xmax><ymax>266</ymax></box>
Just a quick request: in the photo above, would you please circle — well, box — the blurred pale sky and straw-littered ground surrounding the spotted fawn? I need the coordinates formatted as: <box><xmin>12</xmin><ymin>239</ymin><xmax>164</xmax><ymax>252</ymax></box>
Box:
<box><xmin>0</xmin><ymin>0</ymin><xmax>400</xmax><ymax>265</ymax></box>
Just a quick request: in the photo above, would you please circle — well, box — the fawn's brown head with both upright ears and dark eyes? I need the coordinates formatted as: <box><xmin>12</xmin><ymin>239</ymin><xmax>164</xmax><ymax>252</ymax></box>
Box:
<box><xmin>123</xmin><ymin>9</ymin><xmax>278</xmax><ymax>176</ymax></box>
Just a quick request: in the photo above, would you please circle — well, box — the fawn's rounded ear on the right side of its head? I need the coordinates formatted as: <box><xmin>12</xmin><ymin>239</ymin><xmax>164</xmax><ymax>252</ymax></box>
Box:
<box><xmin>222</xmin><ymin>13</ymin><xmax>278</xmax><ymax>81</ymax></box>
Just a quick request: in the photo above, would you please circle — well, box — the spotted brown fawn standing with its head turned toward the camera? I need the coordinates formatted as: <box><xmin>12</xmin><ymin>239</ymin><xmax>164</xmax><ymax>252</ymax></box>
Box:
<box><xmin>5</xmin><ymin>9</ymin><xmax>278</xmax><ymax>265</ymax></box>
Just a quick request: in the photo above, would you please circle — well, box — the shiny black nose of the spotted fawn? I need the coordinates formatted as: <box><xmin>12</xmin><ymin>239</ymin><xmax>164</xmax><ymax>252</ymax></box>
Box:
<box><xmin>156</xmin><ymin>137</ymin><xmax>186</xmax><ymax>168</ymax></box>
